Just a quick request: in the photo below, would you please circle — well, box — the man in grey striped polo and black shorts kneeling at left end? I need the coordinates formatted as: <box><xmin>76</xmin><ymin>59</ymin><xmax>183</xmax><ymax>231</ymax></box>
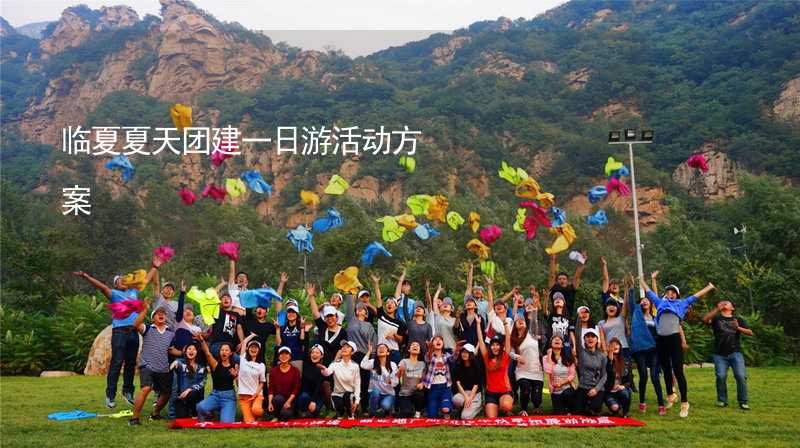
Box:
<box><xmin>128</xmin><ymin>302</ymin><xmax>174</xmax><ymax>426</ymax></box>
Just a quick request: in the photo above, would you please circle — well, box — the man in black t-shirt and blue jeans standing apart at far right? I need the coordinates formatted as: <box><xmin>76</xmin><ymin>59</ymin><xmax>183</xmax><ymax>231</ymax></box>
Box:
<box><xmin>703</xmin><ymin>300</ymin><xmax>753</xmax><ymax>410</ymax></box>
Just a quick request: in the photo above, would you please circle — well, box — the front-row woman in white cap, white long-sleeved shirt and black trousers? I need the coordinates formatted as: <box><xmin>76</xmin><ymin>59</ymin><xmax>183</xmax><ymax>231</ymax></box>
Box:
<box><xmin>322</xmin><ymin>341</ymin><xmax>361</xmax><ymax>418</ymax></box>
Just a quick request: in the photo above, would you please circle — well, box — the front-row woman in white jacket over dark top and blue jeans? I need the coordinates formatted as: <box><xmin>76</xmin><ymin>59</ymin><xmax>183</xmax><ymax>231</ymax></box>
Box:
<box><xmin>361</xmin><ymin>343</ymin><xmax>400</xmax><ymax>417</ymax></box>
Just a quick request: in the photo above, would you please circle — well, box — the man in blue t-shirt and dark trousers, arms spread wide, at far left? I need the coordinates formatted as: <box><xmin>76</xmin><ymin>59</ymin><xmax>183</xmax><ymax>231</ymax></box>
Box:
<box><xmin>72</xmin><ymin>257</ymin><xmax>163</xmax><ymax>408</ymax></box>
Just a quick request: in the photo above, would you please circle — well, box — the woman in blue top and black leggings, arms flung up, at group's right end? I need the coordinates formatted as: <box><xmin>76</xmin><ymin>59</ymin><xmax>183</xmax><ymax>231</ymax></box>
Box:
<box><xmin>639</xmin><ymin>271</ymin><xmax>714</xmax><ymax>418</ymax></box>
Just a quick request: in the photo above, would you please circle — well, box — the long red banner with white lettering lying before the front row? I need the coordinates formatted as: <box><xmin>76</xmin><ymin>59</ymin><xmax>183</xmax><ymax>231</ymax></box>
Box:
<box><xmin>171</xmin><ymin>415</ymin><xmax>644</xmax><ymax>429</ymax></box>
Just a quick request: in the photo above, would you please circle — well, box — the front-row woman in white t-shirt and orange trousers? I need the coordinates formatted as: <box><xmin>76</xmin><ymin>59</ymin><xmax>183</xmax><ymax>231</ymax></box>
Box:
<box><xmin>236</xmin><ymin>333</ymin><xmax>267</xmax><ymax>423</ymax></box>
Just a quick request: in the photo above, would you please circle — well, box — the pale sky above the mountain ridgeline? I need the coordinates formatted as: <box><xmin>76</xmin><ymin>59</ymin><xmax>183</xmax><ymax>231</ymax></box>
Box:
<box><xmin>0</xmin><ymin>0</ymin><xmax>565</xmax><ymax>56</ymax></box>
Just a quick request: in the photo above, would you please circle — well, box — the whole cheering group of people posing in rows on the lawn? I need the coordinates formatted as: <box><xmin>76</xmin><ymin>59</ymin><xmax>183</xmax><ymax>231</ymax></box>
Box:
<box><xmin>73</xmin><ymin>253</ymin><xmax>752</xmax><ymax>425</ymax></box>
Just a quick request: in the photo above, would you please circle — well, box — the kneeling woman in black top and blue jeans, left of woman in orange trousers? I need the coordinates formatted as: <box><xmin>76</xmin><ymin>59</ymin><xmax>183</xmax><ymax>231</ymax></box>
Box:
<box><xmin>197</xmin><ymin>334</ymin><xmax>239</xmax><ymax>423</ymax></box>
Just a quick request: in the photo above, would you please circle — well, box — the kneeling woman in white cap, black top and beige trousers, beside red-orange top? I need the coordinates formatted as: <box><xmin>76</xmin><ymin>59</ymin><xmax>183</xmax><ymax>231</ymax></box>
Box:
<box><xmin>453</xmin><ymin>343</ymin><xmax>486</xmax><ymax>420</ymax></box>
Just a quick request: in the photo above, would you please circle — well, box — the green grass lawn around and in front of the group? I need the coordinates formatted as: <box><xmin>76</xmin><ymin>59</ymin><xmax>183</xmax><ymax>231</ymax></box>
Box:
<box><xmin>0</xmin><ymin>367</ymin><xmax>800</xmax><ymax>448</ymax></box>
